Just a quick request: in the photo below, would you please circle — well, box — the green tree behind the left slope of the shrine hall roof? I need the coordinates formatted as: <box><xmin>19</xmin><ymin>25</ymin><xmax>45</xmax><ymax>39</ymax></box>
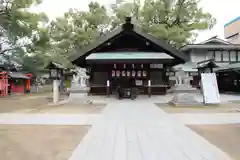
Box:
<box><xmin>49</xmin><ymin>2</ymin><xmax>110</xmax><ymax>66</ymax></box>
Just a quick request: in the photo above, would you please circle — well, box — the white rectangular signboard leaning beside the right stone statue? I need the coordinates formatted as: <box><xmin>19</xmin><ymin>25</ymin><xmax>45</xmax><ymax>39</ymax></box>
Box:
<box><xmin>201</xmin><ymin>73</ymin><xmax>220</xmax><ymax>104</ymax></box>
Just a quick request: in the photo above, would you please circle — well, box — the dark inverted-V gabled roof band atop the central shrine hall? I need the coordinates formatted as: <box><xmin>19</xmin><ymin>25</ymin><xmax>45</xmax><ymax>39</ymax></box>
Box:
<box><xmin>71</xmin><ymin>17</ymin><xmax>189</xmax><ymax>63</ymax></box>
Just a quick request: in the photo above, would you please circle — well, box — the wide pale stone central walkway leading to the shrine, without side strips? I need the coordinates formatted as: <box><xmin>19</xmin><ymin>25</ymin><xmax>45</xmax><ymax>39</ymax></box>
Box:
<box><xmin>69</xmin><ymin>101</ymin><xmax>230</xmax><ymax>160</ymax></box>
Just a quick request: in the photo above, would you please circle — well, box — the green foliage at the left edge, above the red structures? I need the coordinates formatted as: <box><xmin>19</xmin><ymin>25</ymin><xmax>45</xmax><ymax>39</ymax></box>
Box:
<box><xmin>0</xmin><ymin>0</ymin><xmax>50</xmax><ymax>74</ymax></box>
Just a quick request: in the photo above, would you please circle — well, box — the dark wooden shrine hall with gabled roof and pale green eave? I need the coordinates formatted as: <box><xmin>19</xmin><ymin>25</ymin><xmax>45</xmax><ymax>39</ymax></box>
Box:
<box><xmin>72</xmin><ymin>17</ymin><xmax>188</xmax><ymax>95</ymax></box>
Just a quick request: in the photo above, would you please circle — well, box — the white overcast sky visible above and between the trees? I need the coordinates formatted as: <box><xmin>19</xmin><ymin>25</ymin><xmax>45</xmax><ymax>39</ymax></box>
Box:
<box><xmin>32</xmin><ymin>0</ymin><xmax>240</xmax><ymax>43</ymax></box>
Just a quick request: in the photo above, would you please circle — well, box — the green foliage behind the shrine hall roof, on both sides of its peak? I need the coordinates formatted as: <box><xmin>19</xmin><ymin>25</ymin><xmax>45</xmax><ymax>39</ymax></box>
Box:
<box><xmin>50</xmin><ymin>0</ymin><xmax>216</xmax><ymax>63</ymax></box>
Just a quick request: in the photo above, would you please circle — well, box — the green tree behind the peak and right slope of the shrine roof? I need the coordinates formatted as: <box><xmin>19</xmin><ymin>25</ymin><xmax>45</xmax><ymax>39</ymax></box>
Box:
<box><xmin>112</xmin><ymin>0</ymin><xmax>216</xmax><ymax>47</ymax></box>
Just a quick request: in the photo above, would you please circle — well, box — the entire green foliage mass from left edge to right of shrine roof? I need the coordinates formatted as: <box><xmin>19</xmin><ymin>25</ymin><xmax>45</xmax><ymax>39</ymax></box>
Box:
<box><xmin>0</xmin><ymin>0</ymin><xmax>216</xmax><ymax>73</ymax></box>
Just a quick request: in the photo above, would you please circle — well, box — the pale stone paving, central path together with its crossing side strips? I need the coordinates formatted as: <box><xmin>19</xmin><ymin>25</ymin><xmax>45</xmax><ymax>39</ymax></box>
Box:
<box><xmin>0</xmin><ymin>94</ymin><xmax>240</xmax><ymax>160</ymax></box>
